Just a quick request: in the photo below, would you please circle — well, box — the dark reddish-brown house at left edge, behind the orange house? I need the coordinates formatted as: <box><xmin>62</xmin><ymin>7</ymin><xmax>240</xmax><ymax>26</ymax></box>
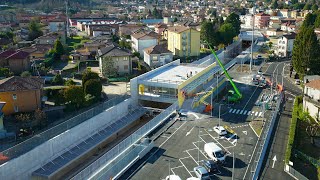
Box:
<box><xmin>0</xmin><ymin>50</ymin><xmax>30</xmax><ymax>75</ymax></box>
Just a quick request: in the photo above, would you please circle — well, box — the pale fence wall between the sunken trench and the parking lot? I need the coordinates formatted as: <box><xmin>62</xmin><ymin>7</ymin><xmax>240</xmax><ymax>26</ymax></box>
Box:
<box><xmin>72</xmin><ymin>102</ymin><xmax>178</xmax><ymax>180</ymax></box>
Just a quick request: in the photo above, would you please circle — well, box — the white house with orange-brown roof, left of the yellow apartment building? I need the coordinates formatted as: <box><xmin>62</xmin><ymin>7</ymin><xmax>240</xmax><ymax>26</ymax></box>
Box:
<box><xmin>131</xmin><ymin>31</ymin><xmax>160</xmax><ymax>56</ymax></box>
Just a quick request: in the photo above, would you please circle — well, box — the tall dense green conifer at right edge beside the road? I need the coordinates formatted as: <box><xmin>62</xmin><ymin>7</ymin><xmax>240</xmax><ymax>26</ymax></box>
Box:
<box><xmin>292</xmin><ymin>27</ymin><xmax>320</xmax><ymax>77</ymax></box>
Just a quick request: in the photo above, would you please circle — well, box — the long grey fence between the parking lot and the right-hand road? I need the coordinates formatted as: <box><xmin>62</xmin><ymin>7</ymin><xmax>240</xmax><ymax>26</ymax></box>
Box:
<box><xmin>250</xmin><ymin>93</ymin><xmax>283</xmax><ymax>180</ymax></box>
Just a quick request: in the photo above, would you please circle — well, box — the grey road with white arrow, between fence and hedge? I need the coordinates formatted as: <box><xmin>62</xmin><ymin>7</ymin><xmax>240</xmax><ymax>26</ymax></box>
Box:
<box><xmin>260</xmin><ymin>62</ymin><xmax>302</xmax><ymax>180</ymax></box>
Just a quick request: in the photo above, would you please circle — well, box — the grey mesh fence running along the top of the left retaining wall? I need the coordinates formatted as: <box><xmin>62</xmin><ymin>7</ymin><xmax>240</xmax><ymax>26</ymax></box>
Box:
<box><xmin>0</xmin><ymin>95</ymin><xmax>129</xmax><ymax>165</ymax></box>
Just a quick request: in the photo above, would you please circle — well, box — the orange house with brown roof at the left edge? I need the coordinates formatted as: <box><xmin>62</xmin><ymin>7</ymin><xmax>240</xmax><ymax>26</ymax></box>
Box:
<box><xmin>0</xmin><ymin>76</ymin><xmax>44</xmax><ymax>115</ymax></box>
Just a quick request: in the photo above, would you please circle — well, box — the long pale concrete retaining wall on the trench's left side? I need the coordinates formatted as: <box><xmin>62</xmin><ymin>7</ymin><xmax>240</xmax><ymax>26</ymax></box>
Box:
<box><xmin>0</xmin><ymin>98</ymin><xmax>137</xmax><ymax>180</ymax></box>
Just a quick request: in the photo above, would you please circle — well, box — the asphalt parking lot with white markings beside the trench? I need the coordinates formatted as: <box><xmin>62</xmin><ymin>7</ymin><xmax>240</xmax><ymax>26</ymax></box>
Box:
<box><xmin>121</xmin><ymin>75</ymin><xmax>270</xmax><ymax>180</ymax></box>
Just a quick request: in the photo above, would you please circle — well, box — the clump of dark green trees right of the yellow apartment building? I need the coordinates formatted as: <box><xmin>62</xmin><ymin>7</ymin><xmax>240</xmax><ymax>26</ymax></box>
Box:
<box><xmin>200</xmin><ymin>13</ymin><xmax>241</xmax><ymax>46</ymax></box>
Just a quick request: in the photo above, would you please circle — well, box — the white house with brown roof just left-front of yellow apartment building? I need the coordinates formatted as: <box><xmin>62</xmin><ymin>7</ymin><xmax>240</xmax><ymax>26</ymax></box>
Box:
<box><xmin>144</xmin><ymin>44</ymin><xmax>173</xmax><ymax>68</ymax></box>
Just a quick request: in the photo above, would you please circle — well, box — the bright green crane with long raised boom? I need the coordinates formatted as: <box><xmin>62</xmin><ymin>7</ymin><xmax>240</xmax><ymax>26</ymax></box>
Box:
<box><xmin>206</xmin><ymin>42</ymin><xmax>242</xmax><ymax>102</ymax></box>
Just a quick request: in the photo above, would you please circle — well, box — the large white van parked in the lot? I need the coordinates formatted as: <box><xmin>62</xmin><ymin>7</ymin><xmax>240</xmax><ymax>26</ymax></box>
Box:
<box><xmin>204</xmin><ymin>142</ymin><xmax>226</xmax><ymax>163</ymax></box>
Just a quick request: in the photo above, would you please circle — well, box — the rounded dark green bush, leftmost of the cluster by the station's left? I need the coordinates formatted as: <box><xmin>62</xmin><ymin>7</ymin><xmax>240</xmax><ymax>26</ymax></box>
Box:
<box><xmin>63</xmin><ymin>86</ymin><xmax>85</xmax><ymax>108</ymax></box>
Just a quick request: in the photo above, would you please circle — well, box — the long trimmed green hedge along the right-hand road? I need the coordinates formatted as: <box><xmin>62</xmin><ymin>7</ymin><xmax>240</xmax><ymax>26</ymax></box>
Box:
<box><xmin>285</xmin><ymin>96</ymin><xmax>302</xmax><ymax>164</ymax></box>
